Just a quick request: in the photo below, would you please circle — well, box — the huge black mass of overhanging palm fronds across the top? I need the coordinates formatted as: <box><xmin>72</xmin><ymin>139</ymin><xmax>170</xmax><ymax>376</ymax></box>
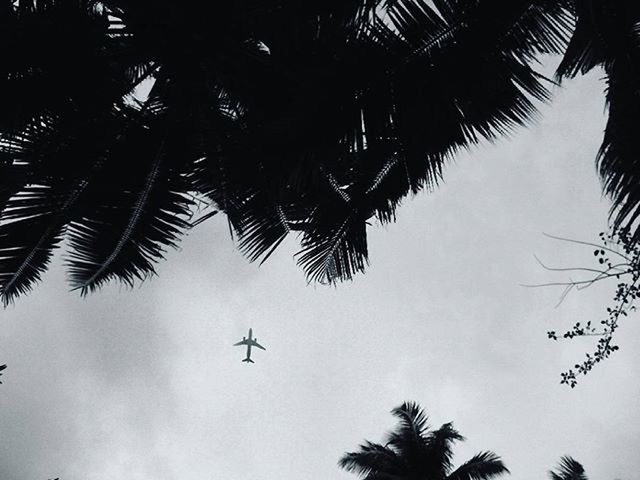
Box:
<box><xmin>0</xmin><ymin>0</ymin><xmax>640</xmax><ymax>304</ymax></box>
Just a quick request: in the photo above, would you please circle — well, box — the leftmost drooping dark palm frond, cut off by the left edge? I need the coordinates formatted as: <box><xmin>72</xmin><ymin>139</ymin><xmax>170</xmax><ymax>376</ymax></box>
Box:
<box><xmin>0</xmin><ymin>111</ymin><xmax>102</xmax><ymax>306</ymax></box>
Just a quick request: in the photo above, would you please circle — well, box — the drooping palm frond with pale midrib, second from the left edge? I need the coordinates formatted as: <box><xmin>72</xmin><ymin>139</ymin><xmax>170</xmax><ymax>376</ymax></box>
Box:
<box><xmin>66</xmin><ymin>127</ymin><xmax>191</xmax><ymax>295</ymax></box>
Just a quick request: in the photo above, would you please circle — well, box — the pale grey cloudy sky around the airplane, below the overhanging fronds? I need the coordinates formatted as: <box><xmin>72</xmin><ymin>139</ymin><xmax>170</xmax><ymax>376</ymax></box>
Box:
<box><xmin>0</xmin><ymin>63</ymin><xmax>640</xmax><ymax>480</ymax></box>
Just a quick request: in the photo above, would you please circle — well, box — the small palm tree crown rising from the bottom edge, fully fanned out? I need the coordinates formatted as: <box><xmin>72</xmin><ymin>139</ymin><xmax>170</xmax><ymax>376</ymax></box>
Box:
<box><xmin>338</xmin><ymin>402</ymin><xmax>509</xmax><ymax>480</ymax></box>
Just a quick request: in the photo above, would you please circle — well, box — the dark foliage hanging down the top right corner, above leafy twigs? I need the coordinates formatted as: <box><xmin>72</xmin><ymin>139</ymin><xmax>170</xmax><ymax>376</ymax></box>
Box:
<box><xmin>557</xmin><ymin>0</ymin><xmax>640</xmax><ymax>242</ymax></box>
